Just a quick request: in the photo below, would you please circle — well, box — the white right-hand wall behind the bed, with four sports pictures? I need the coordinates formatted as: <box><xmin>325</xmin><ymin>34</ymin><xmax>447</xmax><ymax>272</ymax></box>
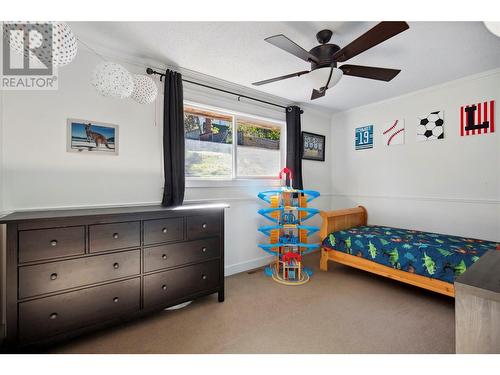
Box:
<box><xmin>330</xmin><ymin>70</ymin><xmax>500</xmax><ymax>241</ymax></box>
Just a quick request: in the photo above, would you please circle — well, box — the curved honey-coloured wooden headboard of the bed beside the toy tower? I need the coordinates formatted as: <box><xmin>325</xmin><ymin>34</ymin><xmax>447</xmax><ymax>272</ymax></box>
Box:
<box><xmin>319</xmin><ymin>206</ymin><xmax>368</xmax><ymax>241</ymax></box>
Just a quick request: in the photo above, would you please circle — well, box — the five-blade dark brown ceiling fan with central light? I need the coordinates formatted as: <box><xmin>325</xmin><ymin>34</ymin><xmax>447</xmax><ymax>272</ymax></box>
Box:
<box><xmin>253</xmin><ymin>21</ymin><xmax>409</xmax><ymax>100</ymax></box>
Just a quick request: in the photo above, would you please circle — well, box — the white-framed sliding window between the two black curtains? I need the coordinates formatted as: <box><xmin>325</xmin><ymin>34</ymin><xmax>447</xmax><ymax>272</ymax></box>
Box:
<box><xmin>184</xmin><ymin>105</ymin><xmax>283</xmax><ymax>179</ymax></box>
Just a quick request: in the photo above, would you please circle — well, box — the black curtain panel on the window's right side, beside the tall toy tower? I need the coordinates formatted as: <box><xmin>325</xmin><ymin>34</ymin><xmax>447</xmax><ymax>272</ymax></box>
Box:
<box><xmin>286</xmin><ymin>106</ymin><xmax>303</xmax><ymax>190</ymax></box>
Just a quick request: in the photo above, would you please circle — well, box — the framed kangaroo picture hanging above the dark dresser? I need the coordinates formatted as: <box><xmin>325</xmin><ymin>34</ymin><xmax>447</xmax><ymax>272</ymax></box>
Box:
<box><xmin>66</xmin><ymin>119</ymin><xmax>118</xmax><ymax>155</ymax></box>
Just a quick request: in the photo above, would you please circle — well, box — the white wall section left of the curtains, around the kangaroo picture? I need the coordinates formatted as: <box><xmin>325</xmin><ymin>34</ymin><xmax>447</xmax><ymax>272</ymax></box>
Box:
<box><xmin>3</xmin><ymin>51</ymin><xmax>161</xmax><ymax>210</ymax></box>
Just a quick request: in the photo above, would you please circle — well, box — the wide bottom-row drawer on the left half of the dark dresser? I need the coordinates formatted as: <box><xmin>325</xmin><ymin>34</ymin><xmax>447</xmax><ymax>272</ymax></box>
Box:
<box><xmin>19</xmin><ymin>278</ymin><xmax>141</xmax><ymax>341</ymax></box>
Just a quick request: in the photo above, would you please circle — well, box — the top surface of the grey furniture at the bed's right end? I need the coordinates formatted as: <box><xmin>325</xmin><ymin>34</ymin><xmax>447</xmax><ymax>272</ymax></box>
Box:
<box><xmin>455</xmin><ymin>250</ymin><xmax>500</xmax><ymax>293</ymax></box>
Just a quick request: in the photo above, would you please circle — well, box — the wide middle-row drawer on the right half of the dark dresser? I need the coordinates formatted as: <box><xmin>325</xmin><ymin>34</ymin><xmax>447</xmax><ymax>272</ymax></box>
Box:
<box><xmin>144</xmin><ymin>237</ymin><xmax>220</xmax><ymax>272</ymax></box>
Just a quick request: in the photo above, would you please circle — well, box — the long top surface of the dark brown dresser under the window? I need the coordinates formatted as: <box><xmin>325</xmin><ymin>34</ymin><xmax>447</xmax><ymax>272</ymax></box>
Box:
<box><xmin>0</xmin><ymin>203</ymin><xmax>229</xmax><ymax>224</ymax></box>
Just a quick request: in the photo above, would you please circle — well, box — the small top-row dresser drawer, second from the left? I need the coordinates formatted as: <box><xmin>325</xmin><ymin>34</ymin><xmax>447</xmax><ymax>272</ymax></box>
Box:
<box><xmin>89</xmin><ymin>221</ymin><xmax>141</xmax><ymax>252</ymax></box>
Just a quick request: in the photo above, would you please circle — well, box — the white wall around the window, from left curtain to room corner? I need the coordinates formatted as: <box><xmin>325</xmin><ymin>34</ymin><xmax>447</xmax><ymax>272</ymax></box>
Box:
<box><xmin>184</xmin><ymin>73</ymin><xmax>331</xmax><ymax>274</ymax></box>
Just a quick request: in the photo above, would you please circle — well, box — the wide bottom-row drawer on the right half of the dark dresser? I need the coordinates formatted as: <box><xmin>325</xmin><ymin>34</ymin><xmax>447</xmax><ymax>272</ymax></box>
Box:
<box><xmin>143</xmin><ymin>260</ymin><xmax>220</xmax><ymax>309</ymax></box>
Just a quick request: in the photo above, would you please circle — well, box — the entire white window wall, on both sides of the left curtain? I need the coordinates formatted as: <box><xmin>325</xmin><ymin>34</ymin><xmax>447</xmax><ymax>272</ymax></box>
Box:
<box><xmin>1</xmin><ymin>48</ymin><xmax>331</xmax><ymax>273</ymax></box>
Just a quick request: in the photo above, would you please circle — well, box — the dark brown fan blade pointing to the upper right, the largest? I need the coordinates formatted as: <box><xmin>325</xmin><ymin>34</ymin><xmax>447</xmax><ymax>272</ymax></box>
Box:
<box><xmin>332</xmin><ymin>21</ymin><xmax>410</xmax><ymax>61</ymax></box>
